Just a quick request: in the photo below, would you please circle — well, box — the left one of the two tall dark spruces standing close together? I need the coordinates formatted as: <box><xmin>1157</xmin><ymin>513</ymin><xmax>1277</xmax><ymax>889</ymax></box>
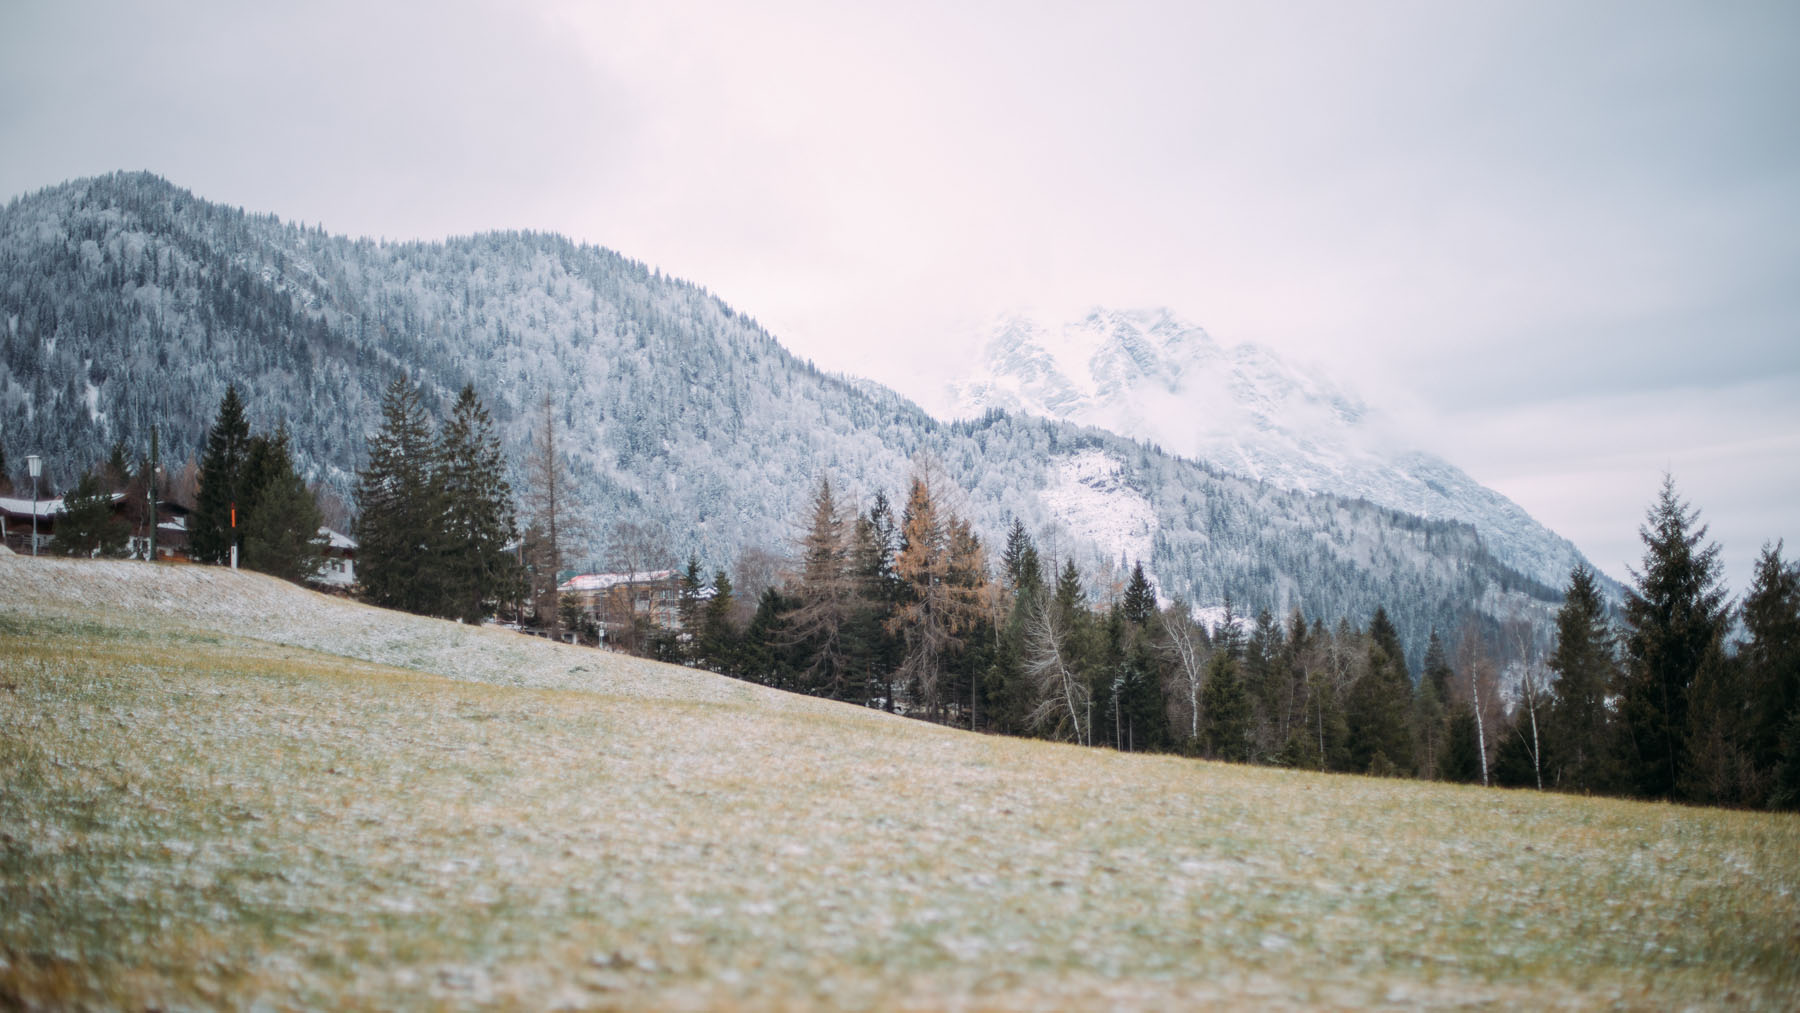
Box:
<box><xmin>356</xmin><ymin>380</ymin><xmax>446</xmax><ymax>615</ymax></box>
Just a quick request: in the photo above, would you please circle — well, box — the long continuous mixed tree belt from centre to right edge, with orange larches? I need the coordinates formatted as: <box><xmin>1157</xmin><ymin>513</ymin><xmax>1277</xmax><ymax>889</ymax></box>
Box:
<box><xmin>659</xmin><ymin>477</ymin><xmax>1800</xmax><ymax>808</ymax></box>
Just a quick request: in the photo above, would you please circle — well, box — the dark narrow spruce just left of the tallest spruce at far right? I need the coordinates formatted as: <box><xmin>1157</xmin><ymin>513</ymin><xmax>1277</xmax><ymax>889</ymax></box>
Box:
<box><xmin>1548</xmin><ymin>563</ymin><xmax>1618</xmax><ymax>792</ymax></box>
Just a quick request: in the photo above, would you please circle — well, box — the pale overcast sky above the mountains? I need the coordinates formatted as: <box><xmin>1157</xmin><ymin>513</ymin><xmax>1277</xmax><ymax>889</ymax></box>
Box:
<box><xmin>0</xmin><ymin>0</ymin><xmax>1800</xmax><ymax>592</ymax></box>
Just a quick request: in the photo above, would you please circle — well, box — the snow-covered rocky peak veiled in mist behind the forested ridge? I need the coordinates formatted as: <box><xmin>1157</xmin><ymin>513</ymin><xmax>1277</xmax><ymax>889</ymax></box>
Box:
<box><xmin>950</xmin><ymin>308</ymin><xmax>1582</xmax><ymax>587</ymax></box>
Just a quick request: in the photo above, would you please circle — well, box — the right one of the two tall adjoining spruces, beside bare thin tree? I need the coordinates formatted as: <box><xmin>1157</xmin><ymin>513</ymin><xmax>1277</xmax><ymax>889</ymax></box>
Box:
<box><xmin>437</xmin><ymin>387</ymin><xmax>524</xmax><ymax>623</ymax></box>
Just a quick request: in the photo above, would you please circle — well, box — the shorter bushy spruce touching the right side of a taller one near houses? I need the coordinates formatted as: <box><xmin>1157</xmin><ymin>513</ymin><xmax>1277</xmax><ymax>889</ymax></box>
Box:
<box><xmin>238</xmin><ymin>428</ymin><xmax>324</xmax><ymax>581</ymax></box>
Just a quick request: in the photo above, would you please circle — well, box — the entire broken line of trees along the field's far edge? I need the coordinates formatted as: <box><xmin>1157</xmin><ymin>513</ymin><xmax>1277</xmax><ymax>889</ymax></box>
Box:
<box><xmin>21</xmin><ymin>372</ymin><xmax>1800</xmax><ymax>810</ymax></box>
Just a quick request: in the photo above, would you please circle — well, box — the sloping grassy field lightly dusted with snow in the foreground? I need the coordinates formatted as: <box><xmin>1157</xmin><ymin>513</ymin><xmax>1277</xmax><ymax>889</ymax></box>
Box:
<box><xmin>0</xmin><ymin>556</ymin><xmax>1800</xmax><ymax>1009</ymax></box>
